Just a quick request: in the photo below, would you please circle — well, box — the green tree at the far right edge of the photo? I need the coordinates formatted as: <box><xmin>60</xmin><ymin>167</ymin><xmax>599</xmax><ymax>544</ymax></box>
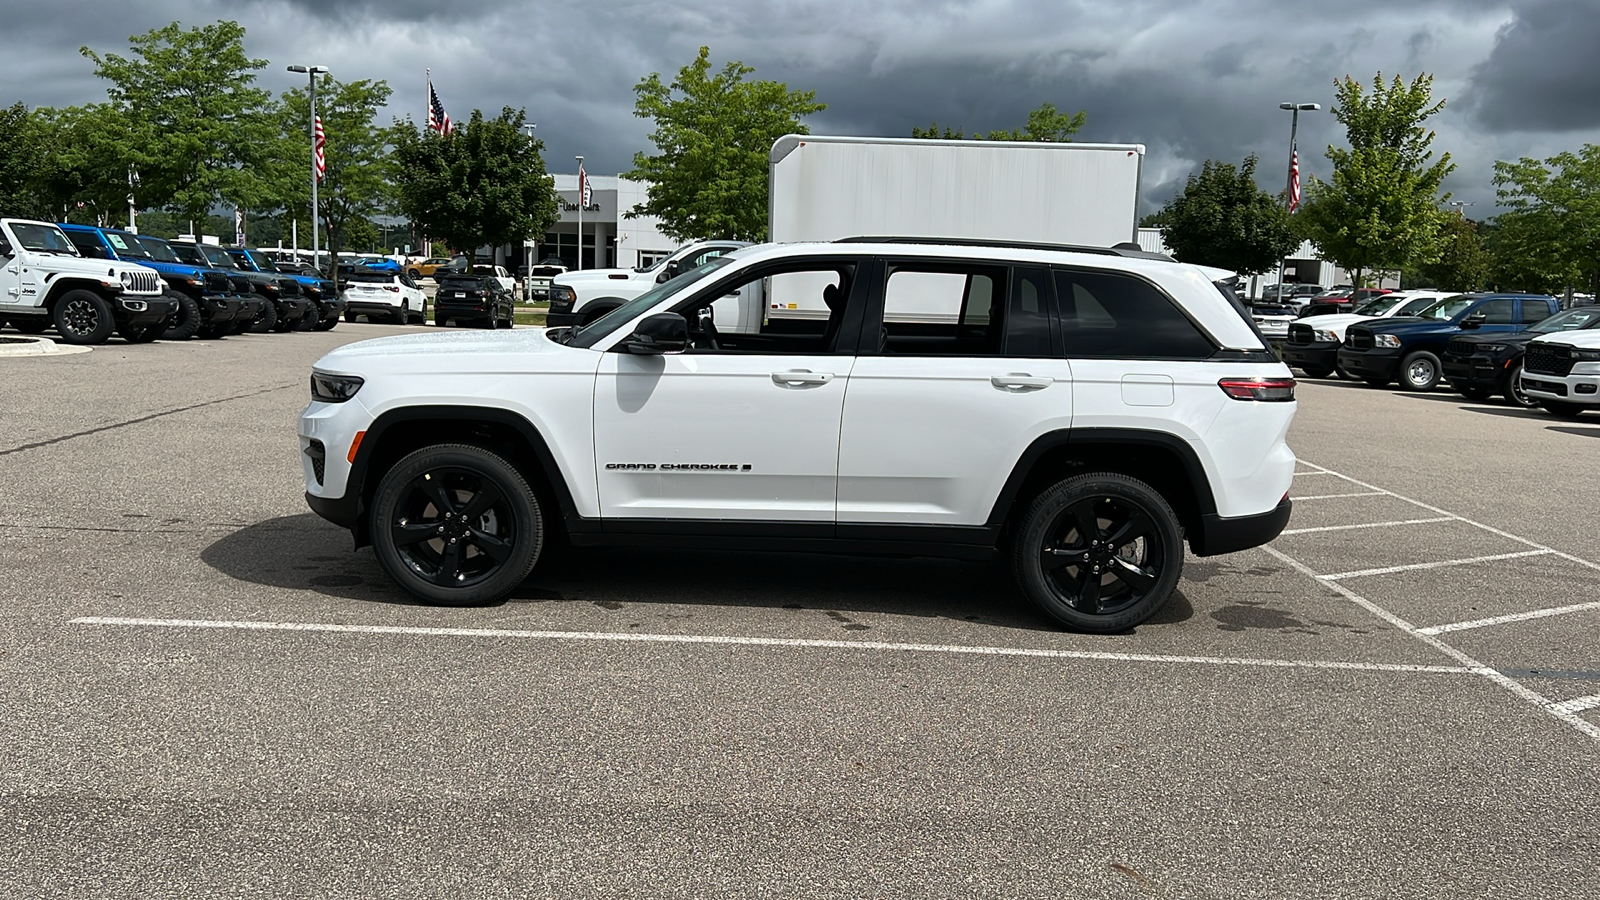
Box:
<box><xmin>1494</xmin><ymin>144</ymin><xmax>1600</xmax><ymax>290</ymax></box>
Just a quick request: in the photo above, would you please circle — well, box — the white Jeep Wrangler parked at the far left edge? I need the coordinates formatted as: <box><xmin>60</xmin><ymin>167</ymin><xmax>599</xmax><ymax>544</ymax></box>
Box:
<box><xmin>0</xmin><ymin>219</ymin><xmax>178</xmax><ymax>344</ymax></box>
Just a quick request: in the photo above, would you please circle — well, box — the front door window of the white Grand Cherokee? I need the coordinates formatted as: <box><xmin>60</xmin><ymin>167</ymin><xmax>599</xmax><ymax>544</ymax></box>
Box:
<box><xmin>674</xmin><ymin>261</ymin><xmax>856</xmax><ymax>354</ymax></box>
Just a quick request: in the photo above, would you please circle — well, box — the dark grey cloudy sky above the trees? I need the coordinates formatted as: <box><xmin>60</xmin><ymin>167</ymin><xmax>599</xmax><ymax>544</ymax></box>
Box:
<box><xmin>0</xmin><ymin>0</ymin><xmax>1600</xmax><ymax>218</ymax></box>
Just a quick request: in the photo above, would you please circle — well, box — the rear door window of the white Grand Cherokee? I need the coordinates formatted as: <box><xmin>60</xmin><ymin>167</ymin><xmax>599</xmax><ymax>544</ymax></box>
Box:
<box><xmin>869</xmin><ymin>263</ymin><xmax>1004</xmax><ymax>356</ymax></box>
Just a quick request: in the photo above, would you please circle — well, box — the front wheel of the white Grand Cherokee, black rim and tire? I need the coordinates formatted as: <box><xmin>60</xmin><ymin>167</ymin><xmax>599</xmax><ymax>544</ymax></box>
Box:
<box><xmin>370</xmin><ymin>444</ymin><xmax>544</xmax><ymax>605</ymax></box>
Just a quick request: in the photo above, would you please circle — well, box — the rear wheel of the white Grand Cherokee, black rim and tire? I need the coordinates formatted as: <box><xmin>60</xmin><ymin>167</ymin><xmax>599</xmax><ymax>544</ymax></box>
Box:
<box><xmin>1011</xmin><ymin>472</ymin><xmax>1184</xmax><ymax>634</ymax></box>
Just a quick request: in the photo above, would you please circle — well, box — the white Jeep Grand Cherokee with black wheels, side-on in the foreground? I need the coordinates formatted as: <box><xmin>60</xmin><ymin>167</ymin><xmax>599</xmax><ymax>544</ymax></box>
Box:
<box><xmin>299</xmin><ymin>239</ymin><xmax>1294</xmax><ymax>633</ymax></box>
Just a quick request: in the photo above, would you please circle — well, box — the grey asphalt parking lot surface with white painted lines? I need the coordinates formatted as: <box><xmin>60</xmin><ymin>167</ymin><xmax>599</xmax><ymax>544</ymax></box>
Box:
<box><xmin>0</xmin><ymin>323</ymin><xmax>1600</xmax><ymax>898</ymax></box>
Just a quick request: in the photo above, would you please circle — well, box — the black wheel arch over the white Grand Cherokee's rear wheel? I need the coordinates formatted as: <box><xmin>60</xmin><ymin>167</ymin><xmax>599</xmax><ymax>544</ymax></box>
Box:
<box><xmin>989</xmin><ymin>428</ymin><xmax>1216</xmax><ymax>547</ymax></box>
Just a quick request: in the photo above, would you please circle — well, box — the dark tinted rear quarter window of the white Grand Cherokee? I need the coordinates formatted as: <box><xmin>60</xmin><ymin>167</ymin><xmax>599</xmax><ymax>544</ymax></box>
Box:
<box><xmin>1056</xmin><ymin>269</ymin><xmax>1216</xmax><ymax>359</ymax></box>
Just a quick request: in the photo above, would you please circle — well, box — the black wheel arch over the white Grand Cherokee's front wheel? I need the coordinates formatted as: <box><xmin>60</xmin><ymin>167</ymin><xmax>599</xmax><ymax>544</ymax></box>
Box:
<box><xmin>344</xmin><ymin>405</ymin><xmax>581</xmax><ymax>546</ymax></box>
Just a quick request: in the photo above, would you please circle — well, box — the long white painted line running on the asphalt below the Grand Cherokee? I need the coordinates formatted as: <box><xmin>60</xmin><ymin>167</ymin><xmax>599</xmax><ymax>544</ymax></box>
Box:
<box><xmin>70</xmin><ymin>615</ymin><xmax>1482</xmax><ymax>674</ymax></box>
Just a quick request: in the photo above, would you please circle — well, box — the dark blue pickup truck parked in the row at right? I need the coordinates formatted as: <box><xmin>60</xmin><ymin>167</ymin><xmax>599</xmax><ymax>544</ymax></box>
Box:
<box><xmin>1339</xmin><ymin>293</ymin><xmax>1560</xmax><ymax>391</ymax></box>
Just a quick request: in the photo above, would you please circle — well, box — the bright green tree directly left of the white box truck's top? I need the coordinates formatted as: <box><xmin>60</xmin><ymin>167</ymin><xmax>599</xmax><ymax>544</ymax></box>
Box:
<box><xmin>624</xmin><ymin>46</ymin><xmax>826</xmax><ymax>240</ymax></box>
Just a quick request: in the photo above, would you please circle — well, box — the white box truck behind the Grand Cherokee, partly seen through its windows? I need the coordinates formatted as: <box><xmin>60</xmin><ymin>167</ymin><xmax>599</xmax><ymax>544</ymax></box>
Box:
<box><xmin>717</xmin><ymin>135</ymin><xmax>1144</xmax><ymax>330</ymax></box>
